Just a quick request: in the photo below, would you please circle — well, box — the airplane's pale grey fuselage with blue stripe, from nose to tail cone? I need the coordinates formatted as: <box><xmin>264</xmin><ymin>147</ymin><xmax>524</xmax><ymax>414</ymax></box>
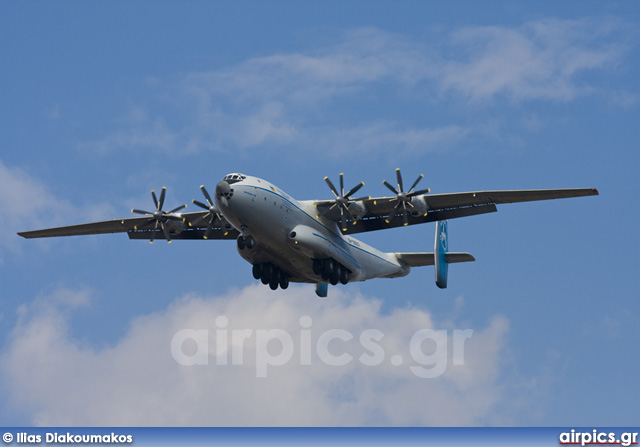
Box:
<box><xmin>215</xmin><ymin>174</ymin><xmax>410</xmax><ymax>283</ymax></box>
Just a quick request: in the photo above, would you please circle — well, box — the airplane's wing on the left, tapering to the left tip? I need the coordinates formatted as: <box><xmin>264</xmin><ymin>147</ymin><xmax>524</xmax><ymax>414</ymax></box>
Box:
<box><xmin>18</xmin><ymin>211</ymin><xmax>238</xmax><ymax>239</ymax></box>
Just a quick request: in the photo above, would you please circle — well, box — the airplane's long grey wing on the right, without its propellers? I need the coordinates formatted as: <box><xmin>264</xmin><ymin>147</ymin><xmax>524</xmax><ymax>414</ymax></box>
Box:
<box><xmin>316</xmin><ymin>188</ymin><xmax>598</xmax><ymax>234</ymax></box>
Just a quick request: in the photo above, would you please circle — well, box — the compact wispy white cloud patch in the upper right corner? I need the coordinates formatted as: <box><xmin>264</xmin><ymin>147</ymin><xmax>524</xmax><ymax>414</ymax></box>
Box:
<box><xmin>441</xmin><ymin>19</ymin><xmax>625</xmax><ymax>101</ymax></box>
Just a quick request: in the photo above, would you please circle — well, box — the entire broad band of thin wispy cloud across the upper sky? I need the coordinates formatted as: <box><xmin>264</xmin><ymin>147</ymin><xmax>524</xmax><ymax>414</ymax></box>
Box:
<box><xmin>84</xmin><ymin>18</ymin><xmax>631</xmax><ymax>157</ymax></box>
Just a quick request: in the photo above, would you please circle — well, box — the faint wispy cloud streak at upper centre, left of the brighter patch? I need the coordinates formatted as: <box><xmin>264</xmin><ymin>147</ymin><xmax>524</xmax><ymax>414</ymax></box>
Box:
<box><xmin>182</xmin><ymin>28</ymin><xmax>433</xmax><ymax>107</ymax></box>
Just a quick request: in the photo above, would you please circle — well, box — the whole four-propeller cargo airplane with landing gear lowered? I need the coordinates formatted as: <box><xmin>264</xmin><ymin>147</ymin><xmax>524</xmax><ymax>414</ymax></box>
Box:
<box><xmin>18</xmin><ymin>169</ymin><xmax>598</xmax><ymax>297</ymax></box>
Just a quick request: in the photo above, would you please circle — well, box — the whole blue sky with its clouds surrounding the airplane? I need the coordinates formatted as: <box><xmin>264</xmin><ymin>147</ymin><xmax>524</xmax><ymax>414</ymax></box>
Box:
<box><xmin>0</xmin><ymin>1</ymin><xmax>640</xmax><ymax>426</ymax></box>
